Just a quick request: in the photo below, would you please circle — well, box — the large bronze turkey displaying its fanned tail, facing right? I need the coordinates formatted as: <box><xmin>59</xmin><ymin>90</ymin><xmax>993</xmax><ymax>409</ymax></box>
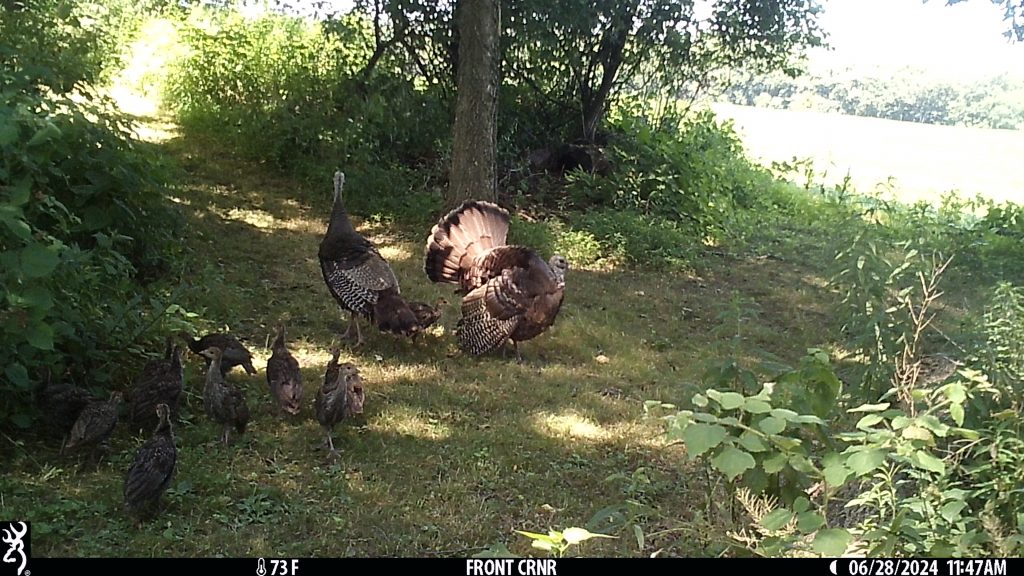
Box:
<box><xmin>424</xmin><ymin>200</ymin><xmax>568</xmax><ymax>362</ymax></box>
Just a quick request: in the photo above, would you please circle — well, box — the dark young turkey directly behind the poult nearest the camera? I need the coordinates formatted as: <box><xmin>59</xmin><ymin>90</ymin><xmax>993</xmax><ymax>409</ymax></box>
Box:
<box><xmin>127</xmin><ymin>337</ymin><xmax>184</xmax><ymax>429</ymax></box>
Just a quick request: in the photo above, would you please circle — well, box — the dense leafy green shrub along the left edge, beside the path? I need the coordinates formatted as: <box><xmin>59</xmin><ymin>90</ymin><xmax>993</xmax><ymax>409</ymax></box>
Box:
<box><xmin>0</xmin><ymin>4</ymin><xmax>189</xmax><ymax>427</ymax></box>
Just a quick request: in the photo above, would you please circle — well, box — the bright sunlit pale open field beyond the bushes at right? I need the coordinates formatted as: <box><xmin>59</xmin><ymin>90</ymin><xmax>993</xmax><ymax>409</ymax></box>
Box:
<box><xmin>713</xmin><ymin>104</ymin><xmax>1024</xmax><ymax>203</ymax></box>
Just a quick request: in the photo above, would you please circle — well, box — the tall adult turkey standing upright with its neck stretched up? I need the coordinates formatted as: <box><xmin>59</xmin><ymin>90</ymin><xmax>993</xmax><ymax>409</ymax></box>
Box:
<box><xmin>318</xmin><ymin>171</ymin><xmax>420</xmax><ymax>344</ymax></box>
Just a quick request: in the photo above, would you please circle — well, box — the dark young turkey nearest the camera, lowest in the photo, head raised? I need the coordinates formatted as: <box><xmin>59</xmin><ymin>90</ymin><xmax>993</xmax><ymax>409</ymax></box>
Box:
<box><xmin>124</xmin><ymin>404</ymin><xmax>177</xmax><ymax>521</ymax></box>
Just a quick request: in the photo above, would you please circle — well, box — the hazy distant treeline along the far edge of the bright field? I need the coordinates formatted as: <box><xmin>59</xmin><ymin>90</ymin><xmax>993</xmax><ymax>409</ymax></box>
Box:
<box><xmin>723</xmin><ymin>70</ymin><xmax>1024</xmax><ymax>129</ymax></box>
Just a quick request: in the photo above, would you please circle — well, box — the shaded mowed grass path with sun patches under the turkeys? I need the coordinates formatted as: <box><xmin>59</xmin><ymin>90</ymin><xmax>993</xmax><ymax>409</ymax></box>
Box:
<box><xmin>0</xmin><ymin>119</ymin><xmax>826</xmax><ymax>557</ymax></box>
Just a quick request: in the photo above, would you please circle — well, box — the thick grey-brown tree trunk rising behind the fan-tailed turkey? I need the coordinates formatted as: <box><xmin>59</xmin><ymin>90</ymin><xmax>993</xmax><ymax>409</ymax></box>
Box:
<box><xmin>445</xmin><ymin>0</ymin><xmax>501</xmax><ymax>208</ymax></box>
